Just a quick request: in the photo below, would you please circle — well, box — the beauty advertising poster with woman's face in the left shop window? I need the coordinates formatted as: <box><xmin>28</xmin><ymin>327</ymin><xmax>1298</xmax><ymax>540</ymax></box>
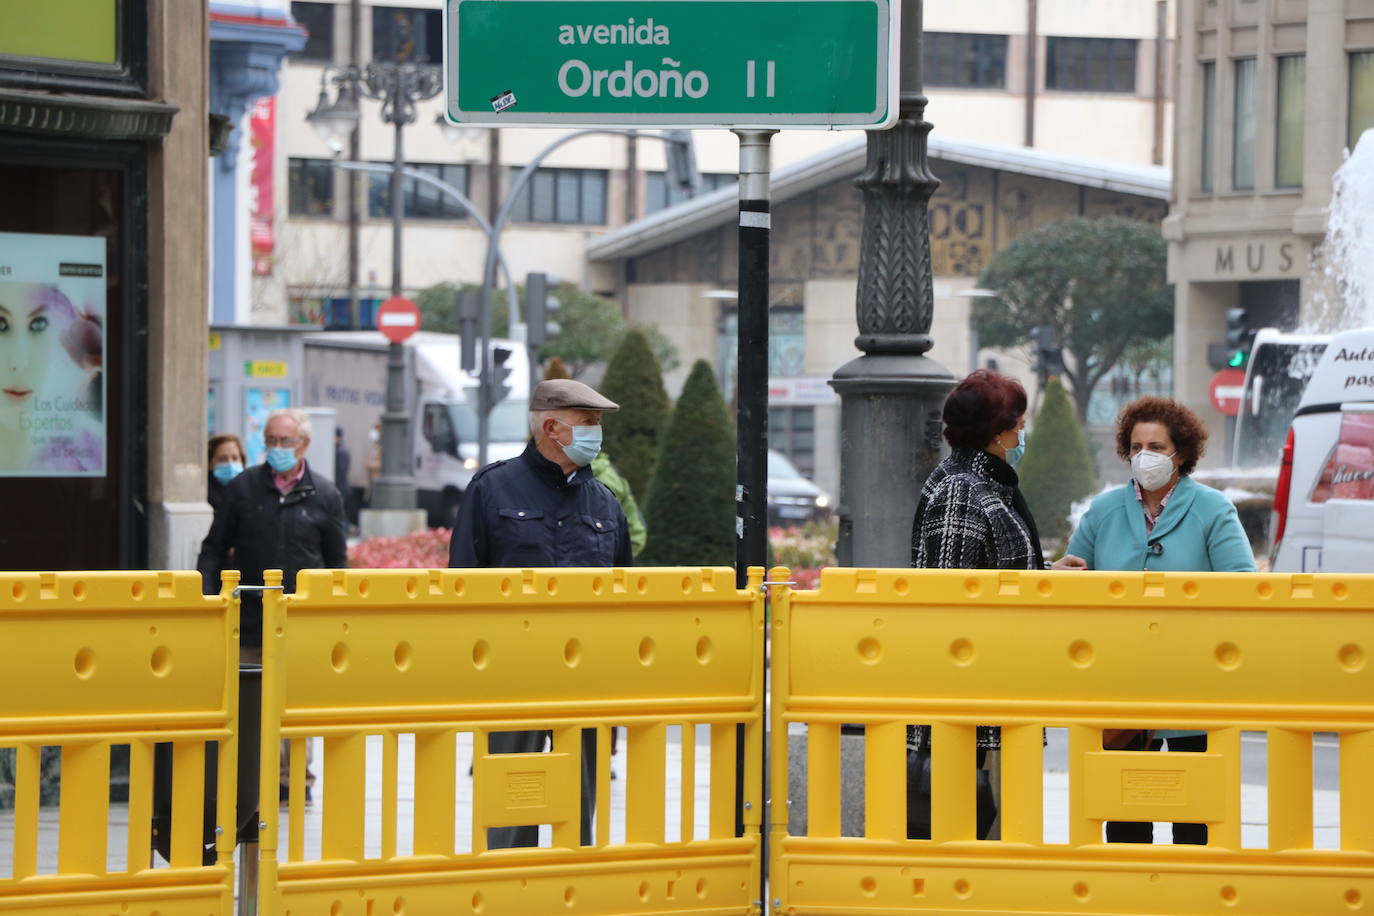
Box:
<box><xmin>0</xmin><ymin>232</ymin><xmax>106</xmax><ymax>477</ymax></box>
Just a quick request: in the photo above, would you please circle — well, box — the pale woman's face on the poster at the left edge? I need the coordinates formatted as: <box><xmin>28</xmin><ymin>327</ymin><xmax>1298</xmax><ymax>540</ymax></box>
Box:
<box><xmin>0</xmin><ymin>283</ymin><xmax>74</xmax><ymax>417</ymax></box>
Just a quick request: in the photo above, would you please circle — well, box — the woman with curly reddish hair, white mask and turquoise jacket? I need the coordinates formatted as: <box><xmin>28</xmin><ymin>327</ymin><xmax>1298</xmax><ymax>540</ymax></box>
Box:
<box><xmin>1054</xmin><ymin>397</ymin><xmax>1254</xmax><ymax>846</ymax></box>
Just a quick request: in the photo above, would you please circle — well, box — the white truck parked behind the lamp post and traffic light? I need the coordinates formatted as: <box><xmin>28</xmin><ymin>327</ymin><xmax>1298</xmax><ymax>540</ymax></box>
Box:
<box><xmin>302</xmin><ymin>331</ymin><xmax>529</xmax><ymax>527</ymax></box>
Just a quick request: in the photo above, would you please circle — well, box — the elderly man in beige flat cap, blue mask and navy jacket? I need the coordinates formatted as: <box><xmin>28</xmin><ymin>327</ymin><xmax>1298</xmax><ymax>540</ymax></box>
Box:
<box><xmin>448</xmin><ymin>379</ymin><xmax>635</xmax><ymax>849</ymax></box>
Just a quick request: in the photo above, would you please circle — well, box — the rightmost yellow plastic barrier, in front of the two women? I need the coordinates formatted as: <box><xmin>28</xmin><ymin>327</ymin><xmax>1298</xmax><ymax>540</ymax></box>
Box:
<box><xmin>768</xmin><ymin>570</ymin><xmax>1374</xmax><ymax>916</ymax></box>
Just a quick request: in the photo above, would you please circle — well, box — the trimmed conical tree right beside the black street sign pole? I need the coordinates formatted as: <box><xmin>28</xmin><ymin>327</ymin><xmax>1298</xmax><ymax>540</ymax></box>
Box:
<box><xmin>636</xmin><ymin>360</ymin><xmax>735</xmax><ymax>566</ymax></box>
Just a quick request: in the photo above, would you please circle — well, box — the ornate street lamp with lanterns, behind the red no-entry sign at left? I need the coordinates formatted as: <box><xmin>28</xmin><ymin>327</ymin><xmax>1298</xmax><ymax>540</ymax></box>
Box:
<box><xmin>305</xmin><ymin>60</ymin><xmax>444</xmax><ymax>509</ymax></box>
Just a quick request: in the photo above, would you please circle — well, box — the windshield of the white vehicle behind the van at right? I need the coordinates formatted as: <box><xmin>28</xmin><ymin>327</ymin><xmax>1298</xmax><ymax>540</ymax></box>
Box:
<box><xmin>1231</xmin><ymin>341</ymin><xmax>1326</xmax><ymax>468</ymax></box>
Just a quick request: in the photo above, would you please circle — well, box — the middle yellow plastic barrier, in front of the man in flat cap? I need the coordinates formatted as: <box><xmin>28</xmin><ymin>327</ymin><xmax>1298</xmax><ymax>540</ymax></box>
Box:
<box><xmin>260</xmin><ymin>569</ymin><xmax>764</xmax><ymax>916</ymax></box>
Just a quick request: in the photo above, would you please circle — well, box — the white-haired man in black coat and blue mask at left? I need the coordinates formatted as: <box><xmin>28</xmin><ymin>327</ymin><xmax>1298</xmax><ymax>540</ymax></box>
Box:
<box><xmin>195</xmin><ymin>409</ymin><xmax>348</xmax><ymax>650</ymax></box>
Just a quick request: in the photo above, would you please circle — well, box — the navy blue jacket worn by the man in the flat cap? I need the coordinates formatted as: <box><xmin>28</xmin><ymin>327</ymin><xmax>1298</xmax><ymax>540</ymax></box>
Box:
<box><xmin>448</xmin><ymin>442</ymin><xmax>635</xmax><ymax>567</ymax></box>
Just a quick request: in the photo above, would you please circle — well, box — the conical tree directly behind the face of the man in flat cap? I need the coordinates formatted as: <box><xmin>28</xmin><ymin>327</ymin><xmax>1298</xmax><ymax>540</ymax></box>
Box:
<box><xmin>600</xmin><ymin>328</ymin><xmax>671</xmax><ymax>494</ymax></box>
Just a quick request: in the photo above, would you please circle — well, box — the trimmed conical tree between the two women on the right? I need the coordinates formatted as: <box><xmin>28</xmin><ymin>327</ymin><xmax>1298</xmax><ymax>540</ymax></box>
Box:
<box><xmin>1017</xmin><ymin>379</ymin><xmax>1098</xmax><ymax>556</ymax></box>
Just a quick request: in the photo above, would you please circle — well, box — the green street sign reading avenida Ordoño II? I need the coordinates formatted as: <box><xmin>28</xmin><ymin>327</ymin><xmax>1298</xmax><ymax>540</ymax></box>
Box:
<box><xmin>444</xmin><ymin>0</ymin><xmax>900</xmax><ymax>129</ymax></box>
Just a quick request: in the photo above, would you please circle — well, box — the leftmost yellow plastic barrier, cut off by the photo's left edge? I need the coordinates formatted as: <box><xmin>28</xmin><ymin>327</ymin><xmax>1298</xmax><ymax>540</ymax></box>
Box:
<box><xmin>0</xmin><ymin>573</ymin><xmax>239</xmax><ymax>916</ymax></box>
